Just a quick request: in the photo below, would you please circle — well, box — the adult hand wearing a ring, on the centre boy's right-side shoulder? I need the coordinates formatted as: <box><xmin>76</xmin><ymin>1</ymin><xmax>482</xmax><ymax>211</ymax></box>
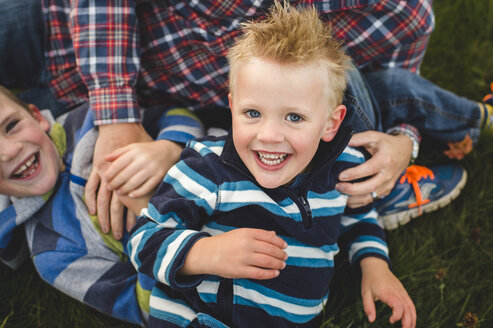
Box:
<box><xmin>336</xmin><ymin>131</ymin><xmax>412</xmax><ymax>207</ymax></box>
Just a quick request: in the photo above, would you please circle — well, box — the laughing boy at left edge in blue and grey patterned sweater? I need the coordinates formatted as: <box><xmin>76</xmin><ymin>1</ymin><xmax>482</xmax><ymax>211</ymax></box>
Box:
<box><xmin>0</xmin><ymin>86</ymin><xmax>202</xmax><ymax>325</ymax></box>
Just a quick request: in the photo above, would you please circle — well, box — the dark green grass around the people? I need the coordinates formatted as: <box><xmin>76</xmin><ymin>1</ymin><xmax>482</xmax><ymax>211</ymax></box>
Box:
<box><xmin>0</xmin><ymin>0</ymin><xmax>493</xmax><ymax>328</ymax></box>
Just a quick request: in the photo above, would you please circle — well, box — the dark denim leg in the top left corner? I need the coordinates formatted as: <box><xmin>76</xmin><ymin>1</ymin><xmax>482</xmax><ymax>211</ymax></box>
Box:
<box><xmin>0</xmin><ymin>0</ymin><xmax>44</xmax><ymax>88</ymax></box>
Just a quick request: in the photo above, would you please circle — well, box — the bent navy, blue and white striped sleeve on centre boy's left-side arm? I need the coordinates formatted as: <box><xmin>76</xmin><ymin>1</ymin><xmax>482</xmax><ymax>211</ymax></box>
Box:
<box><xmin>128</xmin><ymin>148</ymin><xmax>217</xmax><ymax>288</ymax></box>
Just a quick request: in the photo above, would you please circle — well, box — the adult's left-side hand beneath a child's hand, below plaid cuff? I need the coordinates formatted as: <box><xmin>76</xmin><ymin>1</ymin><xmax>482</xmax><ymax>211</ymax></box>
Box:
<box><xmin>84</xmin><ymin>123</ymin><xmax>152</xmax><ymax>239</ymax></box>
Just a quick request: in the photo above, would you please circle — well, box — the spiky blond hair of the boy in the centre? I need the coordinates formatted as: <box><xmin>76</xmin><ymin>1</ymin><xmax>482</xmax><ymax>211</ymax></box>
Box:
<box><xmin>228</xmin><ymin>1</ymin><xmax>349</xmax><ymax>107</ymax></box>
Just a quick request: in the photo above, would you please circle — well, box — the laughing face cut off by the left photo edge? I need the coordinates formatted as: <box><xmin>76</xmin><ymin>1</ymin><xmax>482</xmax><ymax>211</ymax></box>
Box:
<box><xmin>0</xmin><ymin>95</ymin><xmax>60</xmax><ymax>197</ymax></box>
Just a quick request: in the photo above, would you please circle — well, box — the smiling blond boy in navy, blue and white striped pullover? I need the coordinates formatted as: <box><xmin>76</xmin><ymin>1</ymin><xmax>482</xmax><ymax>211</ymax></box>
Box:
<box><xmin>128</xmin><ymin>3</ymin><xmax>416</xmax><ymax>328</ymax></box>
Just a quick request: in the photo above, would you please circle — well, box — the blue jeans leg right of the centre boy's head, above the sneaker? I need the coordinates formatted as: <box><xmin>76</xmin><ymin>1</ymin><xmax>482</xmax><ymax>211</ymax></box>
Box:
<box><xmin>344</xmin><ymin>68</ymin><xmax>481</xmax><ymax>146</ymax></box>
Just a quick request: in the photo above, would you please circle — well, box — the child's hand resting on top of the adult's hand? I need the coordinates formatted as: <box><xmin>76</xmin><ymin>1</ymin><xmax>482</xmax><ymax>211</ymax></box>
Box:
<box><xmin>103</xmin><ymin>140</ymin><xmax>182</xmax><ymax>198</ymax></box>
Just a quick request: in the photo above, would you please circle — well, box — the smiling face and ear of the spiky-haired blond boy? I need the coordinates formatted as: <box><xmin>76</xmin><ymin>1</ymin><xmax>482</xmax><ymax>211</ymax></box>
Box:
<box><xmin>230</xmin><ymin>58</ymin><xmax>345</xmax><ymax>188</ymax></box>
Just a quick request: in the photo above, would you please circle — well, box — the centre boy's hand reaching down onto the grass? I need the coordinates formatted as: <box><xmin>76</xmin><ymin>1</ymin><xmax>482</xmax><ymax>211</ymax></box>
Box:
<box><xmin>360</xmin><ymin>257</ymin><xmax>416</xmax><ymax>328</ymax></box>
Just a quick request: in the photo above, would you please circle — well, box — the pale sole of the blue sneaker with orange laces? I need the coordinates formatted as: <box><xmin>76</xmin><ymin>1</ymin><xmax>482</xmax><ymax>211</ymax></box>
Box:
<box><xmin>378</xmin><ymin>169</ymin><xmax>467</xmax><ymax>230</ymax></box>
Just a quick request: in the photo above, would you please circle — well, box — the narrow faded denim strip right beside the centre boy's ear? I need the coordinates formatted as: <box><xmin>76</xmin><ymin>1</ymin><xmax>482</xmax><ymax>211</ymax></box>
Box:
<box><xmin>343</xmin><ymin>66</ymin><xmax>382</xmax><ymax>132</ymax></box>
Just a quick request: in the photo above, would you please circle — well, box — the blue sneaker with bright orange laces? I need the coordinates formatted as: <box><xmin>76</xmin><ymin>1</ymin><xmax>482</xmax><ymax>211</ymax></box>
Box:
<box><xmin>376</xmin><ymin>164</ymin><xmax>467</xmax><ymax>230</ymax></box>
